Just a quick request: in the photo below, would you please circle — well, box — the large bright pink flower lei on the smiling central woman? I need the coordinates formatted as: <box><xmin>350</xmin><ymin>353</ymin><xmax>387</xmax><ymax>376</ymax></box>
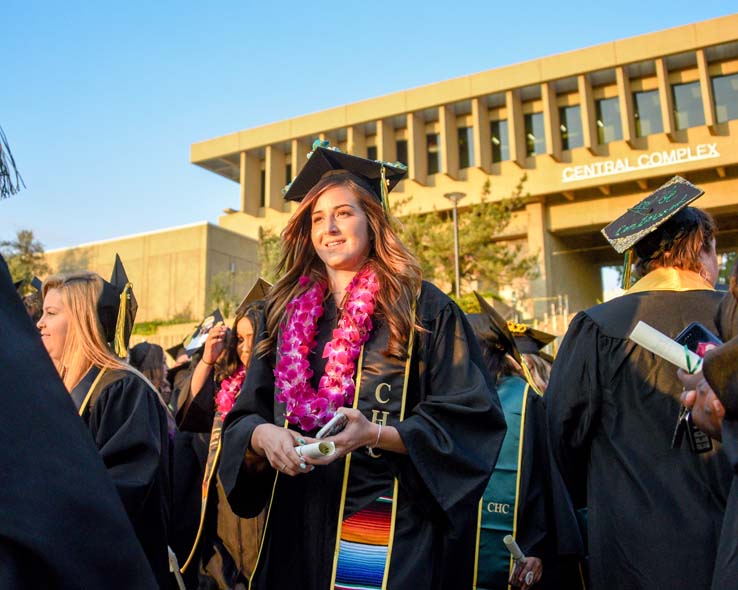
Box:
<box><xmin>274</xmin><ymin>267</ymin><xmax>379</xmax><ymax>432</ymax></box>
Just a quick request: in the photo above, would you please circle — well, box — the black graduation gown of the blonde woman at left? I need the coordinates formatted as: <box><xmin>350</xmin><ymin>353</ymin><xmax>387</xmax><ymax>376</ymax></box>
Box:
<box><xmin>71</xmin><ymin>367</ymin><xmax>171</xmax><ymax>588</ymax></box>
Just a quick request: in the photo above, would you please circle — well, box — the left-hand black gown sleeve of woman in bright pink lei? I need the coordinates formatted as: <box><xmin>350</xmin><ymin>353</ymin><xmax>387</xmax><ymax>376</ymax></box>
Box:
<box><xmin>218</xmin><ymin>313</ymin><xmax>275</xmax><ymax>518</ymax></box>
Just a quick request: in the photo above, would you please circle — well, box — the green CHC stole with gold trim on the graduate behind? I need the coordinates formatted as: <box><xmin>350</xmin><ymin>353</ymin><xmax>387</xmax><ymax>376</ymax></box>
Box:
<box><xmin>474</xmin><ymin>376</ymin><xmax>530</xmax><ymax>590</ymax></box>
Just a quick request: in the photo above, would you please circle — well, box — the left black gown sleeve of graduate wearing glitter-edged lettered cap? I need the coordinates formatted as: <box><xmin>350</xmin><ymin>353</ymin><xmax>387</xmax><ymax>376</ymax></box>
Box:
<box><xmin>546</xmin><ymin>313</ymin><xmax>602</xmax><ymax>506</ymax></box>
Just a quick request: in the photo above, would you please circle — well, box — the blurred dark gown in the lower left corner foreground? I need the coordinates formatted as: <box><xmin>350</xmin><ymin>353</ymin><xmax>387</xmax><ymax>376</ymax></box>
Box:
<box><xmin>0</xmin><ymin>257</ymin><xmax>156</xmax><ymax>590</ymax></box>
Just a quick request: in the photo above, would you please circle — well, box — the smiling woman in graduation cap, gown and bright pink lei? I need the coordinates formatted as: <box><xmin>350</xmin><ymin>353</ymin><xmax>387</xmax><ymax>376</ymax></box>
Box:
<box><xmin>220</xmin><ymin>145</ymin><xmax>505</xmax><ymax>590</ymax></box>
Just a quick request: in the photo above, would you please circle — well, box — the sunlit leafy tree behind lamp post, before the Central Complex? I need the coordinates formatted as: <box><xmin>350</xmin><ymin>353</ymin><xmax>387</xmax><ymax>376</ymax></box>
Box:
<box><xmin>397</xmin><ymin>176</ymin><xmax>538</xmax><ymax>291</ymax></box>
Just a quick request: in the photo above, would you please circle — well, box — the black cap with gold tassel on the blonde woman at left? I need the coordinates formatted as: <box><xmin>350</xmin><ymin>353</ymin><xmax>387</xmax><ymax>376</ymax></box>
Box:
<box><xmin>97</xmin><ymin>254</ymin><xmax>138</xmax><ymax>358</ymax></box>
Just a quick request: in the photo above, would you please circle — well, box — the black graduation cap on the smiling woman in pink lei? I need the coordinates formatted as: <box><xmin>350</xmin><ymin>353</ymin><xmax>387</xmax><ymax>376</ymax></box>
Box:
<box><xmin>282</xmin><ymin>139</ymin><xmax>407</xmax><ymax>211</ymax></box>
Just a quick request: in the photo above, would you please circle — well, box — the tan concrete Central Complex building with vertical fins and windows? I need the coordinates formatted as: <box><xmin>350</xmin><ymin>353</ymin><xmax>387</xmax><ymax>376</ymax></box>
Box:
<box><xmin>191</xmin><ymin>15</ymin><xmax>738</xmax><ymax>316</ymax></box>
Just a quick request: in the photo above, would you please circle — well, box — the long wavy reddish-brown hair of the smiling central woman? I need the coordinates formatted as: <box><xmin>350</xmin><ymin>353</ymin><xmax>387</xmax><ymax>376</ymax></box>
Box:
<box><xmin>257</xmin><ymin>172</ymin><xmax>422</xmax><ymax>357</ymax></box>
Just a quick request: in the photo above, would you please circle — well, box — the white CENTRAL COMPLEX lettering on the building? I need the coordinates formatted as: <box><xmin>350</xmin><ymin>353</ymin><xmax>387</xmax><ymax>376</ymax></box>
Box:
<box><xmin>561</xmin><ymin>143</ymin><xmax>720</xmax><ymax>182</ymax></box>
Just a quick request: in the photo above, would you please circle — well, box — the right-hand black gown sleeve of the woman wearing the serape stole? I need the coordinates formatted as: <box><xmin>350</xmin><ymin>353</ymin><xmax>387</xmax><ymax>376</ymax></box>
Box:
<box><xmin>387</xmin><ymin>301</ymin><xmax>506</xmax><ymax>531</ymax></box>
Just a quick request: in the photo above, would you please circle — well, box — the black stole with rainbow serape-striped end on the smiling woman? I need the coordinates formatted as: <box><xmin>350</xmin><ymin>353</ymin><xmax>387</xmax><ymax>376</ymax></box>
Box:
<box><xmin>330</xmin><ymin>329</ymin><xmax>415</xmax><ymax>590</ymax></box>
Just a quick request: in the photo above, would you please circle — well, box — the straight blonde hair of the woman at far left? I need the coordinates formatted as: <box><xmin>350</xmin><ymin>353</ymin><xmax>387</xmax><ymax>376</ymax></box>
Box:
<box><xmin>42</xmin><ymin>271</ymin><xmax>128</xmax><ymax>391</ymax></box>
